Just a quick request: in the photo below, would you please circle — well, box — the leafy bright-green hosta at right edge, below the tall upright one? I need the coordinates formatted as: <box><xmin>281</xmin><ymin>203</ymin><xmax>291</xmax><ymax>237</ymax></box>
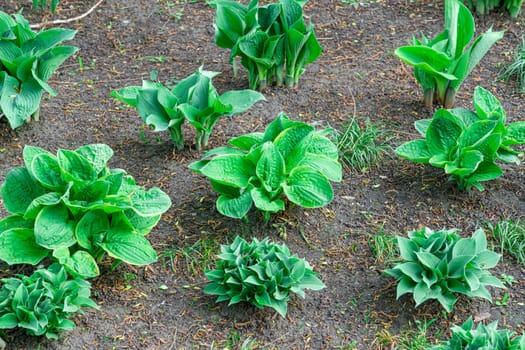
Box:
<box><xmin>396</xmin><ymin>86</ymin><xmax>525</xmax><ymax>191</ymax></box>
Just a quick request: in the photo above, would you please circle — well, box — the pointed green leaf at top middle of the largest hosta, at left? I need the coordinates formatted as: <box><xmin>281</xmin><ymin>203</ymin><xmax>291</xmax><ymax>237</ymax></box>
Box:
<box><xmin>57</xmin><ymin>149</ymin><xmax>98</xmax><ymax>183</ymax></box>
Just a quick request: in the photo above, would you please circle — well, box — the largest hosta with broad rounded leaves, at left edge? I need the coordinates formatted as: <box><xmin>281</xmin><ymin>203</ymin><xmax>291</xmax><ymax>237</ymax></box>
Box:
<box><xmin>0</xmin><ymin>144</ymin><xmax>171</xmax><ymax>278</ymax></box>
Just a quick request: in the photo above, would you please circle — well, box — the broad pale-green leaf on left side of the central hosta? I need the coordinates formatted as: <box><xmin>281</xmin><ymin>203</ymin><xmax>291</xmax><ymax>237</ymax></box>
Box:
<box><xmin>201</xmin><ymin>155</ymin><xmax>255</xmax><ymax>188</ymax></box>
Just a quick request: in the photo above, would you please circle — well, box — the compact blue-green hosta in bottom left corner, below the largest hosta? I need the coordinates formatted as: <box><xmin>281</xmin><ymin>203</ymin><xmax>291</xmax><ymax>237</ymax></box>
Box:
<box><xmin>0</xmin><ymin>264</ymin><xmax>99</xmax><ymax>339</ymax></box>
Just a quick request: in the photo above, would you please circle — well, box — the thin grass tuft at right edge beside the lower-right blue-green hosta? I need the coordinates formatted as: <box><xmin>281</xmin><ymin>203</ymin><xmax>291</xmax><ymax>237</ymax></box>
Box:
<box><xmin>489</xmin><ymin>219</ymin><xmax>525</xmax><ymax>266</ymax></box>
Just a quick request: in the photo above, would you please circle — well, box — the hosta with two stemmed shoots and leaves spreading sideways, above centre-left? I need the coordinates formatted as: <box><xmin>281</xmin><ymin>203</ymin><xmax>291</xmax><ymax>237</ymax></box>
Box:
<box><xmin>111</xmin><ymin>66</ymin><xmax>264</xmax><ymax>150</ymax></box>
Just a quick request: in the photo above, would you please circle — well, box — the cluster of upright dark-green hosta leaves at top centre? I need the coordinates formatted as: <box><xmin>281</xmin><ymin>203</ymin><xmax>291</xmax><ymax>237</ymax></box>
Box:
<box><xmin>210</xmin><ymin>0</ymin><xmax>322</xmax><ymax>90</ymax></box>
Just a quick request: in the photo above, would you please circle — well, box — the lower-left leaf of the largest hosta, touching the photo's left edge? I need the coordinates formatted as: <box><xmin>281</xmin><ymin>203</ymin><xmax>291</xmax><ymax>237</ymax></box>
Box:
<box><xmin>0</xmin><ymin>228</ymin><xmax>48</xmax><ymax>265</ymax></box>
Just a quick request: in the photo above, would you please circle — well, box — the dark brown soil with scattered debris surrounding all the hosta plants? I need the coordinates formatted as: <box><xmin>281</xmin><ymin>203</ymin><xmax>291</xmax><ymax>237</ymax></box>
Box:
<box><xmin>0</xmin><ymin>0</ymin><xmax>525</xmax><ymax>349</ymax></box>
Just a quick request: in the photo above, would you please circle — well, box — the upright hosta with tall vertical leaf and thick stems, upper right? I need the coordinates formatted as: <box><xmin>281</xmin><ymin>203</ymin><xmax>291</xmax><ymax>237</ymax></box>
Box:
<box><xmin>394</xmin><ymin>0</ymin><xmax>503</xmax><ymax>108</ymax></box>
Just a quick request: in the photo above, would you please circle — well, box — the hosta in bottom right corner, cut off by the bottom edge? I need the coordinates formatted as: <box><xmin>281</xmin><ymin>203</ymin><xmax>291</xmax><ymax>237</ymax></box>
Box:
<box><xmin>431</xmin><ymin>317</ymin><xmax>525</xmax><ymax>350</ymax></box>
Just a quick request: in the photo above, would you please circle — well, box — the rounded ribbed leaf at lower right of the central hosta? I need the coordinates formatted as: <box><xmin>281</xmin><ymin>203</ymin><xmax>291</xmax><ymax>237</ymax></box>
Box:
<box><xmin>283</xmin><ymin>166</ymin><xmax>333</xmax><ymax>208</ymax></box>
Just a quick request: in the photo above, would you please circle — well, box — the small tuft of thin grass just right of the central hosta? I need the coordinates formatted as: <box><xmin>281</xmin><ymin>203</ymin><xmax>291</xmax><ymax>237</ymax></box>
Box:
<box><xmin>335</xmin><ymin>117</ymin><xmax>391</xmax><ymax>173</ymax></box>
